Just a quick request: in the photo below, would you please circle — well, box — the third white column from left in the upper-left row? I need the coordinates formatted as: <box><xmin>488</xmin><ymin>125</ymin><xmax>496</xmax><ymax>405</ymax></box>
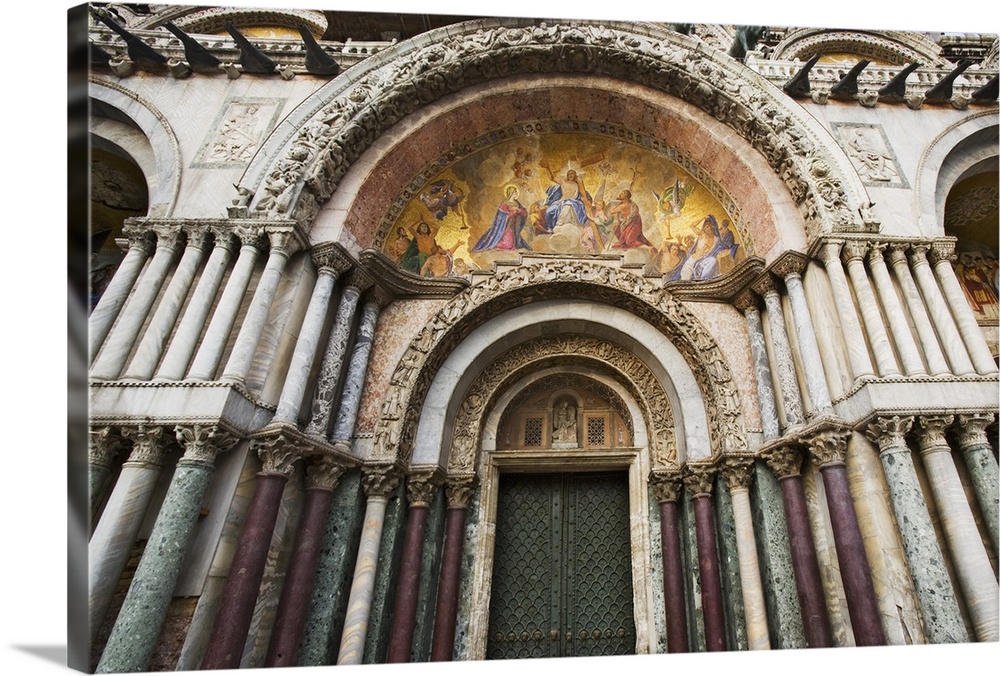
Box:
<box><xmin>122</xmin><ymin>226</ymin><xmax>208</xmax><ymax>380</ymax></box>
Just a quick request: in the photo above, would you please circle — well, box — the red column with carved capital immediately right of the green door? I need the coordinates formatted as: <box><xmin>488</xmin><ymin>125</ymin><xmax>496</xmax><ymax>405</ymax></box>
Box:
<box><xmin>653</xmin><ymin>476</ymin><xmax>688</xmax><ymax>653</ymax></box>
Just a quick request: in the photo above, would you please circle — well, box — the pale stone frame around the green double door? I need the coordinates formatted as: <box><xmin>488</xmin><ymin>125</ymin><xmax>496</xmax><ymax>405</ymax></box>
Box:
<box><xmin>468</xmin><ymin>447</ymin><xmax>656</xmax><ymax>660</ymax></box>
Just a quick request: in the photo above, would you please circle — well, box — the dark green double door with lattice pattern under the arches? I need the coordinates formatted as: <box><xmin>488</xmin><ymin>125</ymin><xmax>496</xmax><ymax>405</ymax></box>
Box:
<box><xmin>486</xmin><ymin>473</ymin><xmax>635</xmax><ymax>659</ymax></box>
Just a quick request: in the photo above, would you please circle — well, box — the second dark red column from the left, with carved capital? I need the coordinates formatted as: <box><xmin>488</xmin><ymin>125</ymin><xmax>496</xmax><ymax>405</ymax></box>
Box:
<box><xmin>264</xmin><ymin>458</ymin><xmax>345</xmax><ymax>667</ymax></box>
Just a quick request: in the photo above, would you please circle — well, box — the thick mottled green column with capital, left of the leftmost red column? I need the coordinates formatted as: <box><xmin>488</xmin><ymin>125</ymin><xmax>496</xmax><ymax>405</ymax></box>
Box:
<box><xmin>97</xmin><ymin>425</ymin><xmax>236</xmax><ymax>673</ymax></box>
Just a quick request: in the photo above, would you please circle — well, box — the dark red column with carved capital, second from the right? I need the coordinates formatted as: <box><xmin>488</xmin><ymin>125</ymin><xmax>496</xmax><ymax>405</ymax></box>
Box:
<box><xmin>765</xmin><ymin>446</ymin><xmax>831</xmax><ymax>648</ymax></box>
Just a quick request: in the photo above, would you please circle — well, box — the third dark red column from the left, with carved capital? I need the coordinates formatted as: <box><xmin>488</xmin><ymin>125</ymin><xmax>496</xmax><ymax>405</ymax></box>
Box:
<box><xmin>386</xmin><ymin>472</ymin><xmax>438</xmax><ymax>663</ymax></box>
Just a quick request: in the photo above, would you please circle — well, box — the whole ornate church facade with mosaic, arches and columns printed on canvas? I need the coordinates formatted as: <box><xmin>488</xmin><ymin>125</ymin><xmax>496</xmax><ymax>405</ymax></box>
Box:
<box><xmin>82</xmin><ymin>3</ymin><xmax>1000</xmax><ymax>673</ymax></box>
